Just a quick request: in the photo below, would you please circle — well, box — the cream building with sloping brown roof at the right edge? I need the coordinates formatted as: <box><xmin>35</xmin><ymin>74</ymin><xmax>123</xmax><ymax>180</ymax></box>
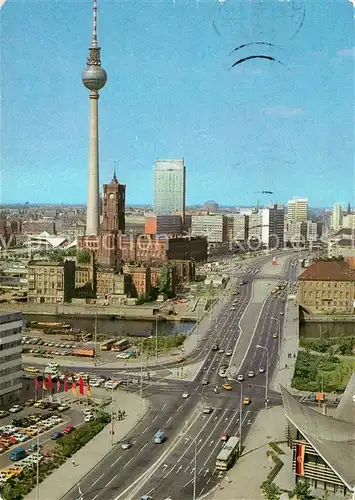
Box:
<box><xmin>298</xmin><ymin>260</ymin><xmax>355</xmax><ymax>313</ymax></box>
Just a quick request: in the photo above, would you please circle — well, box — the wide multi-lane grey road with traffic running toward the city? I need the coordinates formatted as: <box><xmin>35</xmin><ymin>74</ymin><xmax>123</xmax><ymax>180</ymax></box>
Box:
<box><xmin>64</xmin><ymin>257</ymin><xmax>302</xmax><ymax>500</ymax></box>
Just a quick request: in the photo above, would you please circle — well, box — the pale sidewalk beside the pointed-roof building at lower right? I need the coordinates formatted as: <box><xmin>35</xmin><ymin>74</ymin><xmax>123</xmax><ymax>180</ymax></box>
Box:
<box><xmin>209</xmin><ymin>406</ymin><xmax>294</xmax><ymax>500</ymax></box>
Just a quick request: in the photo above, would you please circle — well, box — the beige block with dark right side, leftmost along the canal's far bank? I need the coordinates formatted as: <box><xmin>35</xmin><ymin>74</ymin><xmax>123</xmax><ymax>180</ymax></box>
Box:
<box><xmin>27</xmin><ymin>260</ymin><xmax>75</xmax><ymax>304</ymax></box>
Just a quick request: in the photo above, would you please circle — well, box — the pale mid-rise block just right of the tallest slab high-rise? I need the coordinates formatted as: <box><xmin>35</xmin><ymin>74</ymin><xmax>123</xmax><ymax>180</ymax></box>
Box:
<box><xmin>191</xmin><ymin>215</ymin><xmax>228</xmax><ymax>243</ymax></box>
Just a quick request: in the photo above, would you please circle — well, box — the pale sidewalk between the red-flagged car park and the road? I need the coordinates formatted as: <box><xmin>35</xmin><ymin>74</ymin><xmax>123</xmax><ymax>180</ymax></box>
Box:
<box><xmin>25</xmin><ymin>391</ymin><xmax>149</xmax><ymax>500</ymax></box>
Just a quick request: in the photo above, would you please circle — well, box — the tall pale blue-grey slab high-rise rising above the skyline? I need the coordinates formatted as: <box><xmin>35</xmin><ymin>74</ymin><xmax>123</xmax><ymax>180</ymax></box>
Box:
<box><xmin>153</xmin><ymin>159</ymin><xmax>186</xmax><ymax>220</ymax></box>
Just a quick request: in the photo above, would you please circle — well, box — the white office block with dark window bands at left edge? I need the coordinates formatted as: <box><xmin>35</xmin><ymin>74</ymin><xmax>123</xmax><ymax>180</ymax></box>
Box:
<box><xmin>0</xmin><ymin>313</ymin><xmax>23</xmax><ymax>407</ymax></box>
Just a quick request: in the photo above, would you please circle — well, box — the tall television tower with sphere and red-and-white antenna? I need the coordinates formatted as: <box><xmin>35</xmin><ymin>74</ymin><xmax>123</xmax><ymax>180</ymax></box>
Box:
<box><xmin>81</xmin><ymin>0</ymin><xmax>107</xmax><ymax>236</ymax></box>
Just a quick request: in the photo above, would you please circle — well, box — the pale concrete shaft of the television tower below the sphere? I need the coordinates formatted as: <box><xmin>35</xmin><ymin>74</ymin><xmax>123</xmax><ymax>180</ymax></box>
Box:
<box><xmin>86</xmin><ymin>90</ymin><xmax>100</xmax><ymax>236</ymax></box>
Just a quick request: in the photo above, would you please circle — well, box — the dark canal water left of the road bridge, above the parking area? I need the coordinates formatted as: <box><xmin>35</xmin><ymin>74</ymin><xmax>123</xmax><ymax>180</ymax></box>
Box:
<box><xmin>24</xmin><ymin>314</ymin><xmax>194</xmax><ymax>338</ymax></box>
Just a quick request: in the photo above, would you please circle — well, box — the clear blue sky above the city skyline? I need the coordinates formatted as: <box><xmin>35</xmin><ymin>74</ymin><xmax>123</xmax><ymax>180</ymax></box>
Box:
<box><xmin>1</xmin><ymin>0</ymin><xmax>355</xmax><ymax>206</ymax></box>
